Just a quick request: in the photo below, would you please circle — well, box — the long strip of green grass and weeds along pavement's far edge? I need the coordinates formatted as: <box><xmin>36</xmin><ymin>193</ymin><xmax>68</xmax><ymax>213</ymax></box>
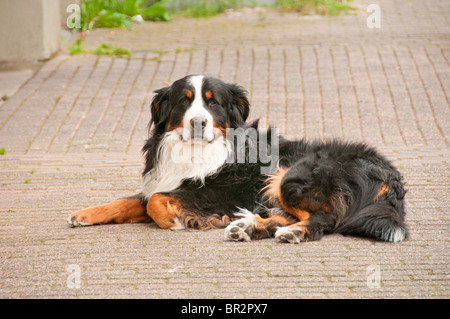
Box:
<box><xmin>77</xmin><ymin>0</ymin><xmax>352</xmax><ymax>27</ymax></box>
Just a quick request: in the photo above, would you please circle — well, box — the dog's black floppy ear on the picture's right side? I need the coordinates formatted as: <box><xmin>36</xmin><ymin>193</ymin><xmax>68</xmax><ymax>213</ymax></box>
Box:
<box><xmin>228</xmin><ymin>84</ymin><xmax>250</xmax><ymax>127</ymax></box>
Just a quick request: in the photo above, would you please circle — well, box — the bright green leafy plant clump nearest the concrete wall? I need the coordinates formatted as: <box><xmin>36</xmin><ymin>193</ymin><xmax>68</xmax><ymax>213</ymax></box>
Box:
<box><xmin>79</xmin><ymin>0</ymin><xmax>170</xmax><ymax>31</ymax></box>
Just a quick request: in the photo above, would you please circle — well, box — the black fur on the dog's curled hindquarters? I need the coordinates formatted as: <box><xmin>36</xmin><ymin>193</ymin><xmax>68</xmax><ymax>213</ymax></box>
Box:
<box><xmin>280</xmin><ymin>140</ymin><xmax>407</xmax><ymax>240</ymax></box>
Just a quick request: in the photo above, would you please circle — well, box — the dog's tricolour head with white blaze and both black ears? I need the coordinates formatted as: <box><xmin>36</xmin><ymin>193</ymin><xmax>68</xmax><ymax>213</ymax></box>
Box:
<box><xmin>151</xmin><ymin>75</ymin><xmax>249</xmax><ymax>143</ymax></box>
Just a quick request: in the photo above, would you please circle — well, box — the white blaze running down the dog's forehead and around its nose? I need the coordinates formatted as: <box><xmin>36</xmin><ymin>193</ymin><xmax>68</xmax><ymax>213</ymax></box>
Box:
<box><xmin>183</xmin><ymin>75</ymin><xmax>214</xmax><ymax>141</ymax></box>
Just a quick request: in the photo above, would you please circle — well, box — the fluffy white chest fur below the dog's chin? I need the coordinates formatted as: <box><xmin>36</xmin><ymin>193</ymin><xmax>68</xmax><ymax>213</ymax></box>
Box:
<box><xmin>142</xmin><ymin>132</ymin><xmax>228</xmax><ymax>199</ymax></box>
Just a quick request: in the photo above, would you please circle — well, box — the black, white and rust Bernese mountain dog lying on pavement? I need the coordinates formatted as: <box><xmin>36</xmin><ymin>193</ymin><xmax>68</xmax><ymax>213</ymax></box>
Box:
<box><xmin>68</xmin><ymin>75</ymin><xmax>407</xmax><ymax>243</ymax></box>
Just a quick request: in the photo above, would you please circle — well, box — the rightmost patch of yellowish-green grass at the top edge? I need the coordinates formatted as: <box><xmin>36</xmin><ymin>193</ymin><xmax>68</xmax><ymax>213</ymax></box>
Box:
<box><xmin>275</xmin><ymin>0</ymin><xmax>353</xmax><ymax>16</ymax></box>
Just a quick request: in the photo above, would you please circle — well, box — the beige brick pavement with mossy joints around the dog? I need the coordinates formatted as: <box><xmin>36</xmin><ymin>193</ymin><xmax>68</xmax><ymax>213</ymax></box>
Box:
<box><xmin>0</xmin><ymin>0</ymin><xmax>450</xmax><ymax>298</ymax></box>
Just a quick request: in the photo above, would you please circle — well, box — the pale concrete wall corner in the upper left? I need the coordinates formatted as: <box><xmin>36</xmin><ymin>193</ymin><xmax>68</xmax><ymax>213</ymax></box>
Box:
<box><xmin>0</xmin><ymin>0</ymin><xmax>61</xmax><ymax>62</ymax></box>
